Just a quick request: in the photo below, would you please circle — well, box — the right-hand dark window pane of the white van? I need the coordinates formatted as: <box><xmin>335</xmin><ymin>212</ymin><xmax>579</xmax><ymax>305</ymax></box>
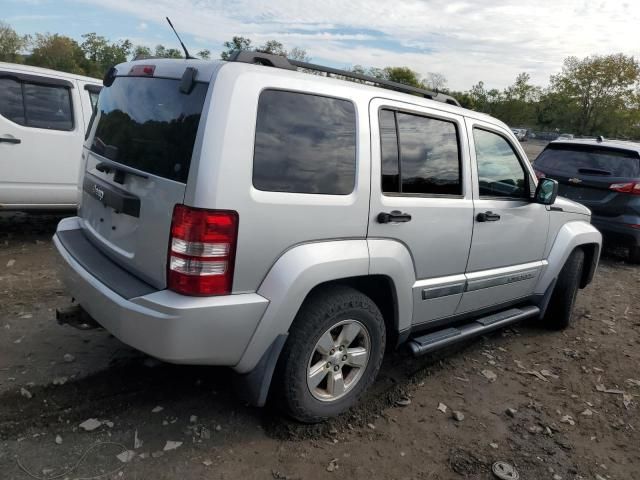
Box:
<box><xmin>24</xmin><ymin>83</ymin><xmax>73</xmax><ymax>130</ymax></box>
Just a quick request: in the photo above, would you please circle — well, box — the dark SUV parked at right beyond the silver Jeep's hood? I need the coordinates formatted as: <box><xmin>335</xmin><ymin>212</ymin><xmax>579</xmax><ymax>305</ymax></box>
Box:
<box><xmin>533</xmin><ymin>137</ymin><xmax>640</xmax><ymax>263</ymax></box>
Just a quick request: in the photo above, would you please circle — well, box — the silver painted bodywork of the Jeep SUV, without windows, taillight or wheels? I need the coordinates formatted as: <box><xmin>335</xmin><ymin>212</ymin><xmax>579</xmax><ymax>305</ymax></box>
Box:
<box><xmin>55</xmin><ymin>60</ymin><xmax>601</xmax><ymax>373</ymax></box>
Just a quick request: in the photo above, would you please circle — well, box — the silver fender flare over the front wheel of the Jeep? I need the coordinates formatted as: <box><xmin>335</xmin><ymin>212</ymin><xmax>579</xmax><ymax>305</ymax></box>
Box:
<box><xmin>534</xmin><ymin>220</ymin><xmax>602</xmax><ymax>295</ymax></box>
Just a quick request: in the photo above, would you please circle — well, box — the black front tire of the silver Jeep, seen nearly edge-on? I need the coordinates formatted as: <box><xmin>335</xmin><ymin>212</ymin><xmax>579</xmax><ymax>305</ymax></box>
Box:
<box><xmin>543</xmin><ymin>248</ymin><xmax>584</xmax><ymax>330</ymax></box>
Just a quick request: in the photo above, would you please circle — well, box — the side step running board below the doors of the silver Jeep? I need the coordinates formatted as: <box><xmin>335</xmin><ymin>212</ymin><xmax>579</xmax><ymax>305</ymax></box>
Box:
<box><xmin>409</xmin><ymin>306</ymin><xmax>540</xmax><ymax>357</ymax></box>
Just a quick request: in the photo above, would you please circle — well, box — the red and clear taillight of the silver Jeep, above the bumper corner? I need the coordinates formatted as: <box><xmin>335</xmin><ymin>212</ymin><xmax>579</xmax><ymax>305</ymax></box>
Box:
<box><xmin>167</xmin><ymin>205</ymin><xmax>238</xmax><ymax>296</ymax></box>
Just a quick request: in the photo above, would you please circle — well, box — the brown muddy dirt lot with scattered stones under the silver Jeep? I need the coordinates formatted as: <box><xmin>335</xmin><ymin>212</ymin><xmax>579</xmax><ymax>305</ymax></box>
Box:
<box><xmin>0</xmin><ymin>208</ymin><xmax>640</xmax><ymax>480</ymax></box>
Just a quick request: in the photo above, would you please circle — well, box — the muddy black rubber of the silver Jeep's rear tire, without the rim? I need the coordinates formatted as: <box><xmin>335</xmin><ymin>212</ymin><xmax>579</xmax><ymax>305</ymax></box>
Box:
<box><xmin>274</xmin><ymin>285</ymin><xmax>386</xmax><ymax>423</ymax></box>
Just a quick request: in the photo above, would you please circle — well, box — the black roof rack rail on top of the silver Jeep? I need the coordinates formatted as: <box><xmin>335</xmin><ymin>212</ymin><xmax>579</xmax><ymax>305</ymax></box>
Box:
<box><xmin>229</xmin><ymin>50</ymin><xmax>460</xmax><ymax>107</ymax></box>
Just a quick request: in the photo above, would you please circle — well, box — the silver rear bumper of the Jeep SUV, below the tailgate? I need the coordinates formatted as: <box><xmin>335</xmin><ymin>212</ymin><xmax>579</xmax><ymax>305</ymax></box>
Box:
<box><xmin>53</xmin><ymin>217</ymin><xmax>268</xmax><ymax>366</ymax></box>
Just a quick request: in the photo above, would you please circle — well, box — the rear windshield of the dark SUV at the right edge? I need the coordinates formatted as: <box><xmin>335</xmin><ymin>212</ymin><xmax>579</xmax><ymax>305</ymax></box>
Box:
<box><xmin>534</xmin><ymin>145</ymin><xmax>640</xmax><ymax>177</ymax></box>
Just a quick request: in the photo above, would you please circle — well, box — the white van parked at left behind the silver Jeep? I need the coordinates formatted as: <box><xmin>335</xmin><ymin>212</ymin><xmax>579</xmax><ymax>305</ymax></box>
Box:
<box><xmin>0</xmin><ymin>62</ymin><xmax>102</xmax><ymax>210</ymax></box>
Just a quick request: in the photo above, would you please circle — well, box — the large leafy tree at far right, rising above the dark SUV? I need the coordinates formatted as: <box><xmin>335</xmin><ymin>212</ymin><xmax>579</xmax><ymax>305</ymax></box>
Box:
<box><xmin>551</xmin><ymin>53</ymin><xmax>640</xmax><ymax>135</ymax></box>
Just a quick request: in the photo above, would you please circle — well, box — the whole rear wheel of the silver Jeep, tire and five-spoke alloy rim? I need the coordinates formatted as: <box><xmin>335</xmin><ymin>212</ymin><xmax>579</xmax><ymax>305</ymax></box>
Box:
<box><xmin>276</xmin><ymin>285</ymin><xmax>386</xmax><ymax>423</ymax></box>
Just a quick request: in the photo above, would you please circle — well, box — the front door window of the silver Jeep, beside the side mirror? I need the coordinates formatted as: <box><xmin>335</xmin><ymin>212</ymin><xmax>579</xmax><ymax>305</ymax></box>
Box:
<box><xmin>473</xmin><ymin>128</ymin><xmax>529</xmax><ymax>197</ymax></box>
